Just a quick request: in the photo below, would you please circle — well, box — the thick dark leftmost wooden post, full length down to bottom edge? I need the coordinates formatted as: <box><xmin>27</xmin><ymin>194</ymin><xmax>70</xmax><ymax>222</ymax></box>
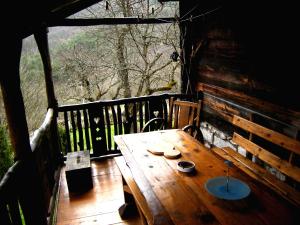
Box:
<box><xmin>0</xmin><ymin>37</ymin><xmax>47</xmax><ymax>225</ymax></box>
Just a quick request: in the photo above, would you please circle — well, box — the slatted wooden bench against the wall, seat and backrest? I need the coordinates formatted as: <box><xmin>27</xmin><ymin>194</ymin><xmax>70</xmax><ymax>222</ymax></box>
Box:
<box><xmin>212</xmin><ymin>116</ymin><xmax>300</xmax><ymax>206</ymax></box>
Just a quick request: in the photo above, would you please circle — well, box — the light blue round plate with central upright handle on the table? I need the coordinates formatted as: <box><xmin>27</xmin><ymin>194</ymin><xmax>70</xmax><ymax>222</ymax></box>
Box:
<box><xmin>205</xmin><ymin>176</ymin><xmax>251</xmax><ymax>200</ymax></box>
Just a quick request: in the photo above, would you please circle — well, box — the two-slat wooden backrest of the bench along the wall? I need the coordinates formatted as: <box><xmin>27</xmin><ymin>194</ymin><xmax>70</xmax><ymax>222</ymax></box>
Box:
<box><xmin>232</xmin><ymin>116</ymin><xmax>300</xmax><ymax>182</ymax></box>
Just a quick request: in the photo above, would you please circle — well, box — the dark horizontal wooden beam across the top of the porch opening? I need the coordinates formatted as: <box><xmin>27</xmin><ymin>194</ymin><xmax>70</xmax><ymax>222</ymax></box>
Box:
<box><xmin>47</xmin><ymin>17</ymin><xmax>176</xmax><ymax>27</ymax></box>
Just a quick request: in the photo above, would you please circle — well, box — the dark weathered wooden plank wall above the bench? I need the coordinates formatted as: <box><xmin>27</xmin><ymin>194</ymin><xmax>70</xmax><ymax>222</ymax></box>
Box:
<box><xmin>181</xmin><ymin>0</ymin><xmax>300</xmax><ymax>138</ymax></box>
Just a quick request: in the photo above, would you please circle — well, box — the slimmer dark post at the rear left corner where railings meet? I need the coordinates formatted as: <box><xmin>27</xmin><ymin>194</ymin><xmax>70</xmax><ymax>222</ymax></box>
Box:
<box><xmin>34</xmin><ymin>27</ymin><xmax>57</xmax><ymax>109</ymax></box>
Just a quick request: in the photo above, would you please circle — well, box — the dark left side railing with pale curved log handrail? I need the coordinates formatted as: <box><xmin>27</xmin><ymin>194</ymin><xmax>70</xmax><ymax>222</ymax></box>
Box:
<box><xmin>0</xmin><ymin>109</ymin><xmax>60</xmax><ymax>225</ymax></box>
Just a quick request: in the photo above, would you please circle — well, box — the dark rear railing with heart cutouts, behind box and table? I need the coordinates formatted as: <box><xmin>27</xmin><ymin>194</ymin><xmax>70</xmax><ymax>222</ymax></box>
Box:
<box><xmin>58</xmin><ymin>94</ymin><xmax>185</xmax><ymax>157</ymax></box>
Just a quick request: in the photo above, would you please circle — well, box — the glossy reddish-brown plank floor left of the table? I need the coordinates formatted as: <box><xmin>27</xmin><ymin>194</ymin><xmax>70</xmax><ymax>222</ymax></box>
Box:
<box><xmin>57</xmin><ymin>159</ymin><xmax>141</xmax><ymax>225</ymax></box>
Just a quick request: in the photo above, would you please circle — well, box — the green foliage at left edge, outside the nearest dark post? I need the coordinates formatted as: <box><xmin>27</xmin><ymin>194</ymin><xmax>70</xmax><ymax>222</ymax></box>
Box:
<box><xmin>0</xmin><ymin>124</ymin><xmax>13</xmax><ymax>180</ymax></box>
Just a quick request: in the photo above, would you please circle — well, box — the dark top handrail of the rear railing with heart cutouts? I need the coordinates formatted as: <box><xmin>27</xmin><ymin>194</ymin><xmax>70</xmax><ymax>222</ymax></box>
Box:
<box><xmin>58</xmin><ymin>93</ymin><xmax>185</xmax><ymax>112</ymax></box>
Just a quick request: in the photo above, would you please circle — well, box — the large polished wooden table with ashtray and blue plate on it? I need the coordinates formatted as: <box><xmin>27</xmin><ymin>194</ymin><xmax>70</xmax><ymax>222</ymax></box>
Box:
<box><xmin>115</xmin><ymin>130</ymin><xmax>300</xmax><ymax>225</ymax></box>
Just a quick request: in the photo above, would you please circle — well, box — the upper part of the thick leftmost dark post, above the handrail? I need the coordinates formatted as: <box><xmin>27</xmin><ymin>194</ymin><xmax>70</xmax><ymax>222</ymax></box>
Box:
<box><xmin>0</xmin><ymin>38</ymin><xmax>31</xmax><ymax>159</ymax></box>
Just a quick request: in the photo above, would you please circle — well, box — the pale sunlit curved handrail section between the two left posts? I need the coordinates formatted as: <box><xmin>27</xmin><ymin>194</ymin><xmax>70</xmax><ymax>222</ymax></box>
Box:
<box><xmin>30</xmin><ymin>108</ymin><xmax>54</xmax><ymax>151</ymax></box>
